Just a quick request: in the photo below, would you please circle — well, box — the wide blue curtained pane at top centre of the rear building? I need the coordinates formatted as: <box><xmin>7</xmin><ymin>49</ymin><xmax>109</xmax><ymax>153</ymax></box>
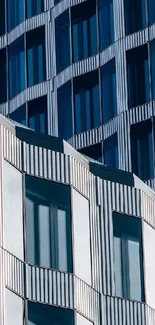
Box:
<box><xmin>71</xmin><ymin>0</ymin><xmax>97</xmax><ymax>62</ymax></box>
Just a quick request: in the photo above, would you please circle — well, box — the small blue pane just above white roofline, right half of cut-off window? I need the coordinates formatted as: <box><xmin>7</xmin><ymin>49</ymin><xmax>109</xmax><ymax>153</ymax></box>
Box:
<box><xmin>103</xmin><ymin>133</ymin><xmax>119</xmax><ymax>168</ymax></box>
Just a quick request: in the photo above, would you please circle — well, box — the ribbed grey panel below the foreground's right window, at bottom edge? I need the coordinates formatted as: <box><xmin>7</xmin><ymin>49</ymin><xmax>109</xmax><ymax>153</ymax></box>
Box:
<box><xmin>101</xmin><ymin>296</ymin><xmax>147</xmax><ymax>325</ymax></box>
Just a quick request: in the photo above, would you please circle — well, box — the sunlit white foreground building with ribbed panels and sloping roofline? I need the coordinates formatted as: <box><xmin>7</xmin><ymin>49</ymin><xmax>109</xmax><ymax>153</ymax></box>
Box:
<box><xmin>0</xmin><ymin>115</ymin><xmax>155</xmax><ymax>325</ymax></box>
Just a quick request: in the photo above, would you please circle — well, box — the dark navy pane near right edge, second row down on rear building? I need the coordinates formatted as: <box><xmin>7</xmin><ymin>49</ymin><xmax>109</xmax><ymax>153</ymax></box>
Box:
<box><xmin>127</xmin><ymin>45</ymin><xmax>150</xmax><ymax>108</ymax></box>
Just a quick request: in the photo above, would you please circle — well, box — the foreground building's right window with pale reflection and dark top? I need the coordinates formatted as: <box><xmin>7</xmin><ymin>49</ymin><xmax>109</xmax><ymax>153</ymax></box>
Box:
<box><xmin>113</xmin><ymin>212</ymin><xmax>144</xmax><ymax>301</ymax></box>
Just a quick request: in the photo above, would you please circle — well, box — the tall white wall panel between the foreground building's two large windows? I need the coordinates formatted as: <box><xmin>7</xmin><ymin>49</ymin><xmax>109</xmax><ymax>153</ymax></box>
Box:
<box><xmin>72</xmin><ymin>189</ymin><xmax>91</xmax><ymax>284</ymax></box>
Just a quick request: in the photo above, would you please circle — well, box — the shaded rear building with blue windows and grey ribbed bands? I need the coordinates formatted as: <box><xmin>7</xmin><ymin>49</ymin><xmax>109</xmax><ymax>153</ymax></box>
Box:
<box><xmin>0</xmin><ymin>0</ymin><xmax>155</xmax><ymax>188</ymax></box>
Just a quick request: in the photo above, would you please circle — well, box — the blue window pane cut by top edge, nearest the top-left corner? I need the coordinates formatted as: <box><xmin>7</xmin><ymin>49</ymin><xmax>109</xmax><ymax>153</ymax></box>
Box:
<box><xmin>7</xmin><ymin>0</ymin><xmax>24</xmax><ymax>31</ymax></box>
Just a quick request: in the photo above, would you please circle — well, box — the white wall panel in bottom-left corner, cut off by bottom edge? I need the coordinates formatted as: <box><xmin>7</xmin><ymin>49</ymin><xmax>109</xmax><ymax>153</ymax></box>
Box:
<box><xmin>4</xmin><ymin>289</ymin><xmax>23</xmax><ymax>325</ymax></box>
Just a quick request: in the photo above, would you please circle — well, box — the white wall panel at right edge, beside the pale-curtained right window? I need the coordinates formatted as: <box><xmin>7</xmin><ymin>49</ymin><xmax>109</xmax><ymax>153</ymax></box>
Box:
<box><xmin>143</xmin><ymin>222</ymin><xmax>155</xmax><ymax>308</ymax></box>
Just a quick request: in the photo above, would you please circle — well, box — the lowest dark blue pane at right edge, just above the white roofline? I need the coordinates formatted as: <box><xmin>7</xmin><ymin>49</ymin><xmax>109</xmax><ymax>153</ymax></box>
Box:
<box><xmin>131</xmin><ymin>120</ymin><xmax>154</xmax><ymax>180</ymax></box>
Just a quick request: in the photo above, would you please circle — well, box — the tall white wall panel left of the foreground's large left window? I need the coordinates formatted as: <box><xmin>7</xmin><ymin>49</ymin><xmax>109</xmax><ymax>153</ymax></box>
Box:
<box><xmin>3</xmin><ymin>160</ymin><xmax>23</xmax><ymax>260</ymax></box>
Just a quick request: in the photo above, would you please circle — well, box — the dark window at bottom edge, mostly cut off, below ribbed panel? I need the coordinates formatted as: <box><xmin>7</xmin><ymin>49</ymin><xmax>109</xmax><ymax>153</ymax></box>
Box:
<box><xmin>27</xmin><ymin>301</ymin><xmax>74</xmax><ymax>325</ymax></box>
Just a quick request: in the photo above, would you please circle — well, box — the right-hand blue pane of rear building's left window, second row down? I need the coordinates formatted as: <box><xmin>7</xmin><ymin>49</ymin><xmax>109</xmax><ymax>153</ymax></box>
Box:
<box><xmin>26</xmin><ymin>27</ymin><xmax>46</xmax><ymax>87</ymax></box>
